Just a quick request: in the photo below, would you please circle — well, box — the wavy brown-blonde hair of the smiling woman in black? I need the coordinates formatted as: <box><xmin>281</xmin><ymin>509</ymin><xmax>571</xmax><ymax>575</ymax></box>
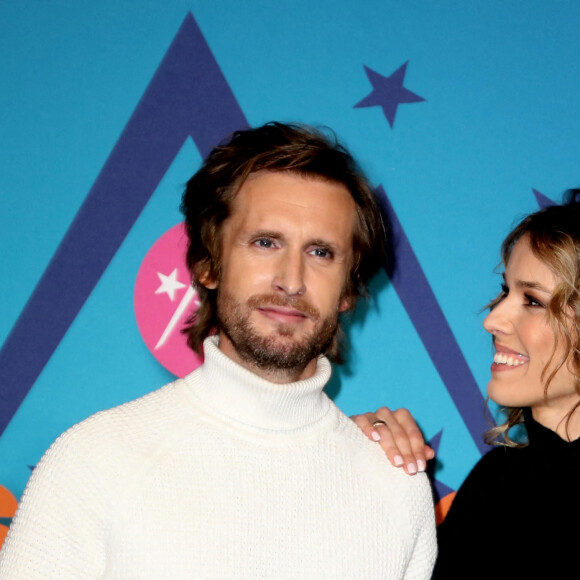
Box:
<box><xmin>484</xmin><ymin>189</ymin><xmax>580</xmax><ymax>447</ymax></box>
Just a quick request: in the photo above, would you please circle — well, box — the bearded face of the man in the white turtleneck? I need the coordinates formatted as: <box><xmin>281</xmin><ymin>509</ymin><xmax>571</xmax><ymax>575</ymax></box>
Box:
<box><xmin>201</xmin><ymin>171</ymin><xmax>356</xmax><ymax>383</ymax></box>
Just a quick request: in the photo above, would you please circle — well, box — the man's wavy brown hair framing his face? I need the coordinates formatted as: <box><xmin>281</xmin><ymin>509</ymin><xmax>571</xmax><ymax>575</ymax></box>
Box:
<box><xmin>181</xmin><ymin>122</ymin><xmax>389</xmax><ymax>362</ymax></box>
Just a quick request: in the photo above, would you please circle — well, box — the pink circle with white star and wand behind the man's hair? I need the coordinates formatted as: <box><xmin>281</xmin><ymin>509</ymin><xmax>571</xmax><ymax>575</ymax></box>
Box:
<box><xmin>133</xmin><ymin>223</ymin><xmax>203</xmax><ymax>377</ymax></box>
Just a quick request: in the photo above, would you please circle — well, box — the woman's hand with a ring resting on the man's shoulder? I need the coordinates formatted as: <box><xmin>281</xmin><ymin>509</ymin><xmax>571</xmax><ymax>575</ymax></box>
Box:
<box><xmin>351</xmin><ymin>407</ymin><xmax>435</xmax><ymax>475</ymax></box>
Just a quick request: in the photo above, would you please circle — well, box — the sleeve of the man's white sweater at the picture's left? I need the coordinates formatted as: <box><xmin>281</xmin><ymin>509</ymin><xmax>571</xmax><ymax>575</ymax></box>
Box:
<box><xmin>0</xmin><ymin>424</ymin><xmax>112</xmax><ymax>580</ymax></box>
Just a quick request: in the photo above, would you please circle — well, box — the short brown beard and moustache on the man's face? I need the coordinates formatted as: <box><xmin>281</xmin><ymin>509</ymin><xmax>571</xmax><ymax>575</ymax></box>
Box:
<box><xmin>217</xmin><ymin>290</ymin><xmax>338</xmax><ymax>371</ymax></box>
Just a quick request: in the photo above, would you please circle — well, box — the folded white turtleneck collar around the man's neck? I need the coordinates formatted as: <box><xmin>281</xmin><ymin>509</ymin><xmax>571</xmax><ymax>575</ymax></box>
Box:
<box><xmin>184</xmin><ymin>336</ymin><xmax>331</xmax><ymax>431</ymax></box>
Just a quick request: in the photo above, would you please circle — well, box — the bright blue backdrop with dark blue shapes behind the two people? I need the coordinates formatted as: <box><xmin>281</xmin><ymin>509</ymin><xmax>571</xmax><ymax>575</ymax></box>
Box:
<box><xmin>0</xmin><ymin>0</ymin><xmax>580</xmax><ymax>540</ymax></box>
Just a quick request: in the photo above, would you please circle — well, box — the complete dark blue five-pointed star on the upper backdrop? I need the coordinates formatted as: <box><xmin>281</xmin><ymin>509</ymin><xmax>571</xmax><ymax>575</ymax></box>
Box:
<box><xmin>354</xmin><ymin>61</ymin><xmax>425</xmax><ymax>128</ymax></box>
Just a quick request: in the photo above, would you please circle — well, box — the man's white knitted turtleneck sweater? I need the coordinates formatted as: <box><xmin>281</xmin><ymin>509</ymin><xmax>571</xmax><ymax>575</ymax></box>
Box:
<box><xmin>0</xmin><ymin>338</ymin><xmax>436</xmax><ymax>580</ymax></box>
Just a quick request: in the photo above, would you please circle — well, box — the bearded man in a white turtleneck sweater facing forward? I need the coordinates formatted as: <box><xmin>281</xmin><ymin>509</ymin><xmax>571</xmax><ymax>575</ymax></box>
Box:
<box><xmin>0</xmin><ymin>123</ymin><xmax>436</xmax><ymax>580</ymax></box>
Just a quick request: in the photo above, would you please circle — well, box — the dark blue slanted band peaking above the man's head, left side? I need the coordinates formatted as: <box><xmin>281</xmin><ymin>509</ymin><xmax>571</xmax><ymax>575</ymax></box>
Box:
<box><xmin>0</xmin><ymin>14</ymin><xmax>247</xmax><ymax>435</ymax></box>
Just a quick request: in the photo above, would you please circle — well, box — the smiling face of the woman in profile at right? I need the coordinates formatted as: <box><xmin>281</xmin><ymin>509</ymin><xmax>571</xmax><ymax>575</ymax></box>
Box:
<box><xmin>483</xmin><ymin>236</ymin><xmax>580</xmax><ymax>432</ymax></box>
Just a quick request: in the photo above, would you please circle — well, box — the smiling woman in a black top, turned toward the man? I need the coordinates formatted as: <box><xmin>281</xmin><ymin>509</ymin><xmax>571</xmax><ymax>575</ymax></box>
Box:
<box><xmin>357</xmin><ymin>189</ymin><xmax>580</xmax><ymax>579</ymax></box>
